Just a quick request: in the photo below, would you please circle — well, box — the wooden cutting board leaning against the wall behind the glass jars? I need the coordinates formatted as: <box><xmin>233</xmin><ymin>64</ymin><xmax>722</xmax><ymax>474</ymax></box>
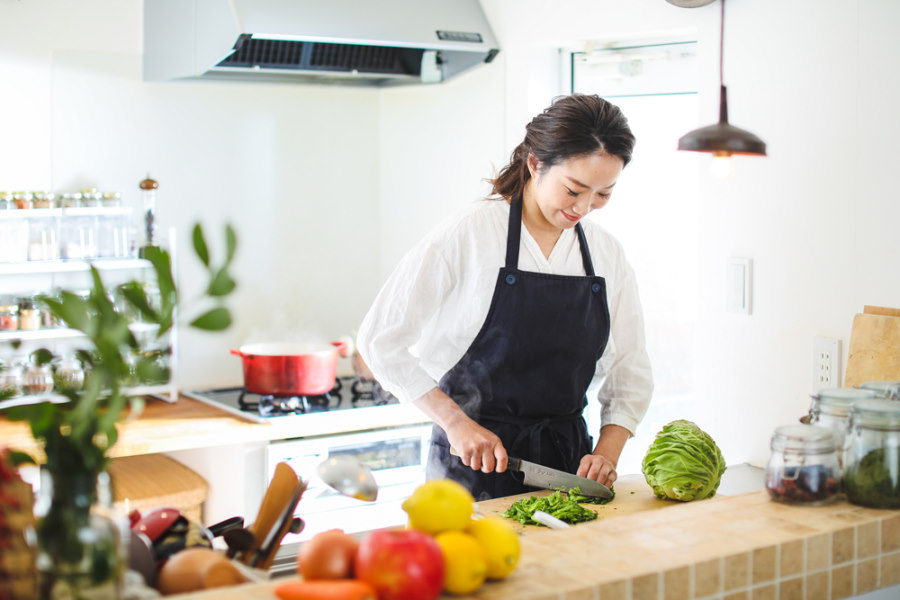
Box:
<box><xmin>844</xmin><ymin>306</ymin><xmax>900</xmax><ymax>387</ymax></box>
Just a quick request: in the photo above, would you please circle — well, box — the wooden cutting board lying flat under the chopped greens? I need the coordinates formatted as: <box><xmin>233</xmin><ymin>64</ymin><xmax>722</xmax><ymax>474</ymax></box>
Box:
<box><xmin>478</xmin><ymin>474</ymin><xmax>680</xmax><ymax>534</ymax></box>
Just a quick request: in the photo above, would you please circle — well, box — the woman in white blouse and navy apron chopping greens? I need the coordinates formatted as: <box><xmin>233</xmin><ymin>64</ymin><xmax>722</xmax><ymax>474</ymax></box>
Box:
<box><xmin>358</xmin><ymin>94</ymin><xmax>653</xmax><ymax>500</ymax></box>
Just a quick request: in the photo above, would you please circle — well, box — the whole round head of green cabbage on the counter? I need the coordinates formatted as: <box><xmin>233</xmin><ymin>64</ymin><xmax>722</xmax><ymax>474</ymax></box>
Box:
<box><xmin>641</xmin><ymin>420</ymin><xmax>725</xmax><ymax>502</ymax></box>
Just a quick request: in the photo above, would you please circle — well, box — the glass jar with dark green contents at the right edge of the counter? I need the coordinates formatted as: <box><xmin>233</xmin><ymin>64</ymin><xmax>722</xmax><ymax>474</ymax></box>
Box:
<box><xmin>844</xmin><ymin>398</ymin><xmax>900</xmax><ymax>508</ymax></box>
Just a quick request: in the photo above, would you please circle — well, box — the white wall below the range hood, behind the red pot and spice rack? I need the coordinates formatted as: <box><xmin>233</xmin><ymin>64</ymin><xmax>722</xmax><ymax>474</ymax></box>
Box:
<box><xmin>0</xmin><ymin>0</ymin><xmax>380</xmax><ymax>387</ymax></box>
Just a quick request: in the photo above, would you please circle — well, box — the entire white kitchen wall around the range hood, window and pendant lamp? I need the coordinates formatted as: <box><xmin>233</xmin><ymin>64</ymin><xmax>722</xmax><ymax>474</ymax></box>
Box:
<box><xmin>0</xmin><ymin>0</ymin><xmax>900</xmax><ymax>463</ymax></box>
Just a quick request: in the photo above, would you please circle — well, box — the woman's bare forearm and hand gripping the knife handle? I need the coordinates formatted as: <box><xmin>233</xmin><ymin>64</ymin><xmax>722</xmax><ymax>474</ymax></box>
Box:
<box><xmin>413</xmin><ymin>387</ymin><xmax>509</xmax><ymax>473</ymax></box>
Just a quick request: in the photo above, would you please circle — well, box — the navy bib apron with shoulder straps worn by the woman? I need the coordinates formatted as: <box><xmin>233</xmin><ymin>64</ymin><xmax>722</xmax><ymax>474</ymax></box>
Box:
<box><xmin>426</xmin><ymin>198</ymin><xmax>609</xmax><ymax>501</ymax></box>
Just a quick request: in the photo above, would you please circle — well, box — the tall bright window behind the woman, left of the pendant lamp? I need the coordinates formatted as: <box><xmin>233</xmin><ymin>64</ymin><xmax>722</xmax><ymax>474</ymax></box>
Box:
<box><xmin>563</xmin><ymin>40</ymin><xmax>700</xmax><ymax>474</ymax></box>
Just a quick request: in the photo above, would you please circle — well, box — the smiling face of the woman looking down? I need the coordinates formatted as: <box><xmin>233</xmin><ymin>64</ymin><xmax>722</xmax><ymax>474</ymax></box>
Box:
<box><xmin>528</xmin><ymin>152</ymin><xmax>625</xmax><ymax>229</ymax></box>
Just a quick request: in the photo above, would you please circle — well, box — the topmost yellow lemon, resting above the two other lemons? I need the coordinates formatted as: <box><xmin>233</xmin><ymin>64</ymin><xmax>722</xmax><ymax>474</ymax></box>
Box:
<box><xmin>402</xmin><ymin>479</ymin><xmax>475</xmax><ymax>535</ymax></box>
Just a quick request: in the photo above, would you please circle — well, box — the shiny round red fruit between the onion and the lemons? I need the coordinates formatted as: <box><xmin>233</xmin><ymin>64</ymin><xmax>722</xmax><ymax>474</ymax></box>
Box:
<box><xmin>354</xmin><ymin>529</ymin><xmax>444</xmax><ymax>600</ymax></box>
